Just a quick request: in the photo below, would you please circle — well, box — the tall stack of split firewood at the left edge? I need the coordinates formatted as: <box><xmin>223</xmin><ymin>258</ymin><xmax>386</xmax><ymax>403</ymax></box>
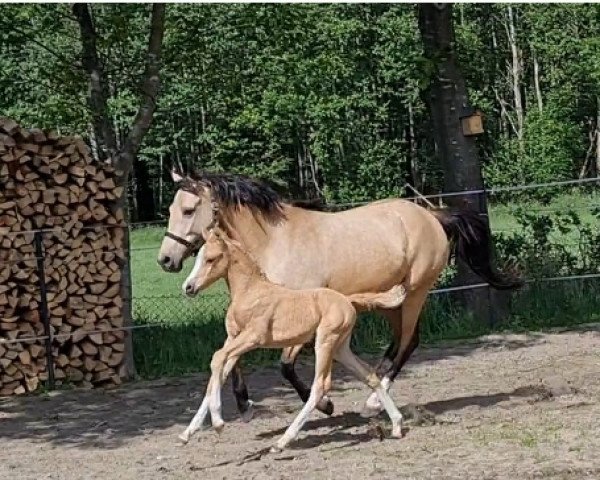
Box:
<box><xmin>0</xmin><ymin>117</ymin><xmax>126</xmax><ymax>395</ymax></box>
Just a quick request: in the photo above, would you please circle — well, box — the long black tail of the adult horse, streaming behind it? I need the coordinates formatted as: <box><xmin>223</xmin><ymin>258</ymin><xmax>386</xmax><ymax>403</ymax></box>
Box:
<box><xmin>432</xmin><ymin>210</ymin><xmax>523</xmax><ymax>290</ymax></box>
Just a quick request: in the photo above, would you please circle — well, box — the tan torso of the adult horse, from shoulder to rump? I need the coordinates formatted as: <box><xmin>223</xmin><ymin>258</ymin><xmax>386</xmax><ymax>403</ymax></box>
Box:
<box><xmin>263</xmin><ymin>199</ymin><xmax>448</xmax><ymax>294</ymax></box>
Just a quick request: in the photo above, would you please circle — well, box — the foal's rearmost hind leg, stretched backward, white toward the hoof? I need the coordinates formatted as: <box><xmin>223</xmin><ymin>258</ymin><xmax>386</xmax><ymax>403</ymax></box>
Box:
<box><xmin>335</xmin><ymin>338</ymin><xmax>402</xmax><ymax>438</ymax></box>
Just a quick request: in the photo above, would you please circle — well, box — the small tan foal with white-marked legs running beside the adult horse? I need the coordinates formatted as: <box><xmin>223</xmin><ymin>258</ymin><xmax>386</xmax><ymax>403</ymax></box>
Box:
<box><xmin>180</xmin><ymin>227</ymin><xmax>406</xmax><ymax>451</ymax></box>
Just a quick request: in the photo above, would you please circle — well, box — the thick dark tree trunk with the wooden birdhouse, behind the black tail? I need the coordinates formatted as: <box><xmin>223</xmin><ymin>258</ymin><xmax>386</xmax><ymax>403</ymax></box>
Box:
<box><xmin>419</xmin><ymin>4</ymin><xmax>490</xmax><ymax>321</ymax></box>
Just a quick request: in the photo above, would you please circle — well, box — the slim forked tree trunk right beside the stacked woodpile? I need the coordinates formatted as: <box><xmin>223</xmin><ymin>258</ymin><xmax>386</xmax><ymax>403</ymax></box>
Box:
<box><xmin>73</xmin><ymin>3</ymin><xmax>165</xmax><ymax>376</ymax></box>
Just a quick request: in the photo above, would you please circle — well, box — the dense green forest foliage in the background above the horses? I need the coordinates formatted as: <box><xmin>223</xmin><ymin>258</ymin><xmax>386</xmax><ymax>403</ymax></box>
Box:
<box><xmin>0</xmin><ymin>4</ymin><xmax>600</xmax><ymax>218</ymax></box>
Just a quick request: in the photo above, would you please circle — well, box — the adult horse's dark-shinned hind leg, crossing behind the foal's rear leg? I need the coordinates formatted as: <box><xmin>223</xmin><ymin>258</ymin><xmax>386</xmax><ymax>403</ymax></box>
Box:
<box><xmin>362</xmin><ymin>285</ymin><xmax>430</xmax><ymax>417</ymax></box>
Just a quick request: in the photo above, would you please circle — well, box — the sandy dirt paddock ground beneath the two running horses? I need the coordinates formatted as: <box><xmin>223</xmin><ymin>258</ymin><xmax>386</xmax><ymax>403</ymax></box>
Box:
<box><xmin>0</xmin><ymin>326</ymin><xmax>600</xmax><ymax>480</ymax></box>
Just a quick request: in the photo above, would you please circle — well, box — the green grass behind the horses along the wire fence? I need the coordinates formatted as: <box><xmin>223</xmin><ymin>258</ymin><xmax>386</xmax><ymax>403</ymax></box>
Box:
<box><xmin>131</xmin><ymin>195</ymin><xmax>600</xmax><ymax>377</ymax></box>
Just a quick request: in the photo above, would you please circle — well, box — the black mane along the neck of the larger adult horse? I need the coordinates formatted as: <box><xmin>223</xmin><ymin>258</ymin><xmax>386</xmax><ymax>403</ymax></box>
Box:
<box><xmin>181</xmin><ymin>172</ymin><xmax>282</xmax><ymax>215</ymax></box>
